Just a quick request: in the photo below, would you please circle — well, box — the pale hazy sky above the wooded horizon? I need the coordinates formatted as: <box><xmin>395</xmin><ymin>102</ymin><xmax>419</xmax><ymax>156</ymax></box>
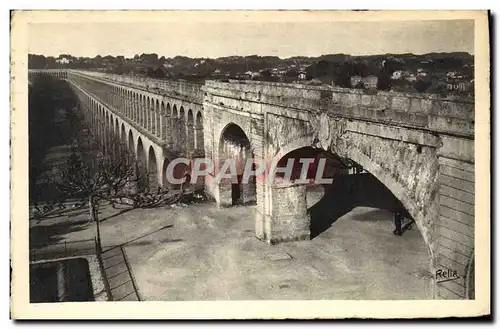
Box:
<box><xmin>29</xmin><ymin>13</ymin><xmax>474</xmax><ymax>58</ymax></box>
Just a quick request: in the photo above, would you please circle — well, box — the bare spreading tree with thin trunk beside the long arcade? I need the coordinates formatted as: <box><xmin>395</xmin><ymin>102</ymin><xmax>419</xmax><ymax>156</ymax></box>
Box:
<box><xmin>45</xmin><ymin>102</ymin><xmax>203</xmax><ymax>252</ymax></box>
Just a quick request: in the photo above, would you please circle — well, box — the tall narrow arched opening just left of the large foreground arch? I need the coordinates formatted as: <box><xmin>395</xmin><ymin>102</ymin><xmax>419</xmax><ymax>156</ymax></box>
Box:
<box><xmin>216</xmin><ymin>123</ymin><xmax>256</xmax><ymax>206</ymax></box>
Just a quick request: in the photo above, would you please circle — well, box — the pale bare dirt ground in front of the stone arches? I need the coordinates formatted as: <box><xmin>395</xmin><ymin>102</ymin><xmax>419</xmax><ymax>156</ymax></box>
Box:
<box><xmin>30</xmin><ymin>187</ymin><xmax>431</xmax><ymax>300</ymax></box>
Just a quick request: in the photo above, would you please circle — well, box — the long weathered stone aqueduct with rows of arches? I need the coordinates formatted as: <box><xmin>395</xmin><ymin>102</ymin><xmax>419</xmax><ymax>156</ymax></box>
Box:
<box><xmin>29</xmin><ymin>70</ymin><xmax>475</xmax><ymax>299</ymax></box>
